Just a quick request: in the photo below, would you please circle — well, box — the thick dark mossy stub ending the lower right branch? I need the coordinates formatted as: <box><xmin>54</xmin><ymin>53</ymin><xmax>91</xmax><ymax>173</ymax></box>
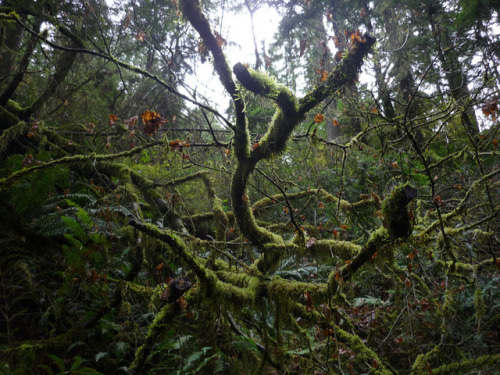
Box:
<box><xmin>382</xmin><ymin>184</ymin><xmax>417</xmax><ymax>239</ymax></box>
